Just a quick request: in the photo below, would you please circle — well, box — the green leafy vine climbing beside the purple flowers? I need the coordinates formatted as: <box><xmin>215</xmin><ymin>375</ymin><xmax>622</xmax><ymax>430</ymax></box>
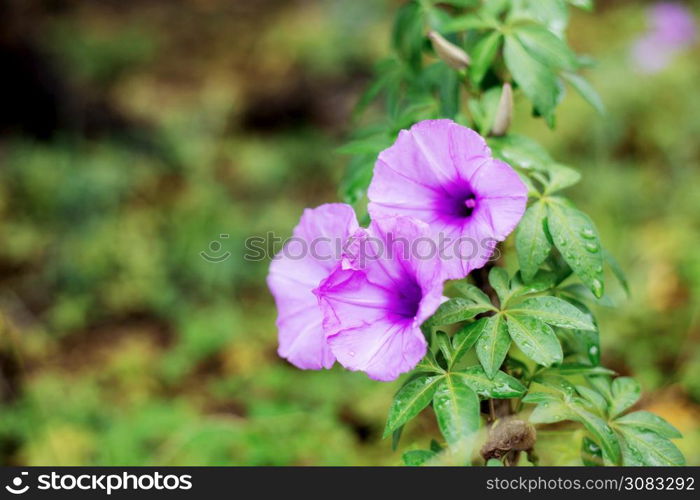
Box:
<box><xmin>340</xmin><ymin>0</ymin><xmax>685</xmax><ymax>465</ymax></box>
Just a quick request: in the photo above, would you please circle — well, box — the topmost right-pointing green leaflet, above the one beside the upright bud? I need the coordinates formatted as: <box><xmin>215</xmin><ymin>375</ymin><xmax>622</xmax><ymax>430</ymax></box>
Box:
<box><xmin>515</xmin><ymin>23</ymin><xmax>578</xmax><ymax>72</ymax></box>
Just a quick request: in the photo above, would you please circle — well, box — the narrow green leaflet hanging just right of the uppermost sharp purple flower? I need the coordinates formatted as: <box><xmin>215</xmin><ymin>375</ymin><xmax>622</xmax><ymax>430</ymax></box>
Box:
<box><xmin>515</xmin><ymin>201</ymin><xmax>552</xmax><ymax>282</ymax></box>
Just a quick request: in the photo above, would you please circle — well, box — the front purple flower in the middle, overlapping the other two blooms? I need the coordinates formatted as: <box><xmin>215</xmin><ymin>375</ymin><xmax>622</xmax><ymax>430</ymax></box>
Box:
<box><xmin>316</xmin><ymin>217</ymin><xmax>444</xmax><ymax>381</ymax></box>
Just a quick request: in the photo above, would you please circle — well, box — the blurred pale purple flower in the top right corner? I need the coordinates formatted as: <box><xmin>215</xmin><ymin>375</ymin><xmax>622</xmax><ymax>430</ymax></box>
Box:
<box><xmin>632</xmin><ymin>2</ymin><xmax>696</xmax><ymax>73</ymax></box>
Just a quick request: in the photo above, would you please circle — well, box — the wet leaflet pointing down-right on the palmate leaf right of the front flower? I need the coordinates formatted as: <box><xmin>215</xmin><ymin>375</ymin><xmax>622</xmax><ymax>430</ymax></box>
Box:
<box><xmin>508</xmin><ymin>314</ymin><xmax>564</xmax><ymax>366</ymax></box>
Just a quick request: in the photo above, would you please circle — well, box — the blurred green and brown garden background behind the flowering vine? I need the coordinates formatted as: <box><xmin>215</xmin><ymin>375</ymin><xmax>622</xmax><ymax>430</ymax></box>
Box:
<box><xmin>0</xmin><ymin>0</ymin><xmax>700</xmax><ymax>465</ymax></box>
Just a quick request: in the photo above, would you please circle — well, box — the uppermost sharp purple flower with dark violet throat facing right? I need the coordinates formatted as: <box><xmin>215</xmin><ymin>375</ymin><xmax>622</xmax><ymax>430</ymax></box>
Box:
<box><xmin>368</xmin><ymin>120</ymin><xmax>527</xmax><ymax>279</ymax></box>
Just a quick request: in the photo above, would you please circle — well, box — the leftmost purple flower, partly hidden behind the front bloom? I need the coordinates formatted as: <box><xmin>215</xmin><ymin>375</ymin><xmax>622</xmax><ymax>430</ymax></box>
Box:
<box><xmin>267</xmin><ymin>203</ymin><xmax>359</xmax><ymax>370</ymax></box>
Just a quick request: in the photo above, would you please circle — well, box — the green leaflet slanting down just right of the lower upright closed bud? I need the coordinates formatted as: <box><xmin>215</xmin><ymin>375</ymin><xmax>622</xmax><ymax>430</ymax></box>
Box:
<box><xmin>503</xmin><ymin>36</ymin><xmax>559</xmax><ymax>124</ymax></box>
